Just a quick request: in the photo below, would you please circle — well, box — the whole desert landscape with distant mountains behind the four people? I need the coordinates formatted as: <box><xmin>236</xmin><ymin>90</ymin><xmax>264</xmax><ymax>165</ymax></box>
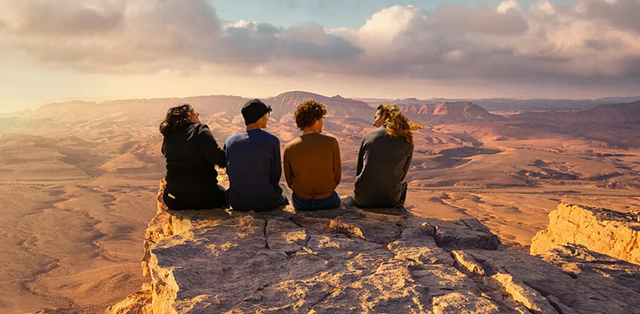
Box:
<box><xmin>0</xmin><ymin>92</ymin><xmax>640</xmax><ymax>313</ymax></box>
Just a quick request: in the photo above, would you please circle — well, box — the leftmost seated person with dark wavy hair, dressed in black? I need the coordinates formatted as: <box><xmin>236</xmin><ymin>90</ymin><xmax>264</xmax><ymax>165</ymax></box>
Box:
<box><xmin>160</xmin><ymin>104</ymin><xmax>227</xmax><ymax>210</ymax></box>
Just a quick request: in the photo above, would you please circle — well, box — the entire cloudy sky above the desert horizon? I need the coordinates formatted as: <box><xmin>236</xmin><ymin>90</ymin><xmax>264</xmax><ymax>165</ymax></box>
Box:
<box><xmin>0</xmin><ymin>0</ymin><xmax>640</xmax><ymax>111</ymax></box>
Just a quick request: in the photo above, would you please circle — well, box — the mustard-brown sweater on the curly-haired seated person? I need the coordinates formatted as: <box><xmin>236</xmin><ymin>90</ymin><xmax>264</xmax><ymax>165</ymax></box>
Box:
<box><xmin>284</xmin><ymin>133</ymin><xmax>341</xmax><ymax>199</ymax></box>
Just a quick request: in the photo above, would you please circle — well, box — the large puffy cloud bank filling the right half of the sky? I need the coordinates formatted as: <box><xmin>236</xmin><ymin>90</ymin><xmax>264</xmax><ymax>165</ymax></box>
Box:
<box><xmin>336</xmin><ymin>0</ymin><xmax>640</xmax><ymax>82</ymax></box>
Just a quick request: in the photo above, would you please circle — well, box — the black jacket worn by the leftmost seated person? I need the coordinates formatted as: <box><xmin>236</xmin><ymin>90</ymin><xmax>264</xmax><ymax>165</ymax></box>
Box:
<box><xmin>162</xmin><ymin>124</ymin><xmax>225</xmax><ymax>194</ymax></box>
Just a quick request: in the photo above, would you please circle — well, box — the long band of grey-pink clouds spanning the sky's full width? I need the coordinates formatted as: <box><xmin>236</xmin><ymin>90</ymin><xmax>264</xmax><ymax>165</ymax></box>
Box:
<box><xmin>0</xmin><ymin>0</ymin><xmax>640</xmax><ymax>83</ymax></box>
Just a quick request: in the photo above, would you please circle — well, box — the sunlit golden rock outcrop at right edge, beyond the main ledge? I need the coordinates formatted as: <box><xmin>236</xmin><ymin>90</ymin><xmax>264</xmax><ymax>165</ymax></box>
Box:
<box><xmin>531</xmin><ymin>203</ymin><xmax>640</xmax><ymax>264</ymax></box>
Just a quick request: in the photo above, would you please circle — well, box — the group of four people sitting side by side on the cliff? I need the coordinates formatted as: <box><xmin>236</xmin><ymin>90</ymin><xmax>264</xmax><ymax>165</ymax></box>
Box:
<box><xmin>160</xmin><ymin>99</ymin><xmax>421</xmax><ymax>212</ymax></box>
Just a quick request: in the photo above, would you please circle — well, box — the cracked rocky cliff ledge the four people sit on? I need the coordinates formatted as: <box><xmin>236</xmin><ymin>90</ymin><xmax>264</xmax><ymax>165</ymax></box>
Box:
<box><xmin>107</xmin><ymin>185</ymin><xmax>640</xmax><ymax>313</ymax></box>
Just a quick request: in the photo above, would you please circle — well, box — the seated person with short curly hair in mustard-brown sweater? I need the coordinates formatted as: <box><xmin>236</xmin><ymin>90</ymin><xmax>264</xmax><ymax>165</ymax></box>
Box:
<box><xmin>283</xmin><ymin>100</ymin><xmax>342</xmax><ymax>210</ymax></box>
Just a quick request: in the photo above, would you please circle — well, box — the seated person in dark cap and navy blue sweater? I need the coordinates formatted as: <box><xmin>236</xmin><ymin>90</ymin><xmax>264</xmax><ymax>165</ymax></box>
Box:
<box><xmin>224</xmin><ymin>99</ymin><xmax>289</xmax><ymax>212</ymax></box>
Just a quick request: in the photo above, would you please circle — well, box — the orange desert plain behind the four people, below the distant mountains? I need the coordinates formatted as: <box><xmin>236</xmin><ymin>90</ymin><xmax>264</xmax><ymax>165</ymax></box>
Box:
<box><xmin>0</xmin><ymin>107</ymin><xmax>640</xmax><ymax>313</ymax></box>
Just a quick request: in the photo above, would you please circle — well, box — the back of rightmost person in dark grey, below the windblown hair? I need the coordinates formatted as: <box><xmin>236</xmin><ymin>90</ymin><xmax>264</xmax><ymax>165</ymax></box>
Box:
<box><xmin>354</xmin><ymin>126</ymin><xmax>413</xmax><ymax>207</ymax></box>
